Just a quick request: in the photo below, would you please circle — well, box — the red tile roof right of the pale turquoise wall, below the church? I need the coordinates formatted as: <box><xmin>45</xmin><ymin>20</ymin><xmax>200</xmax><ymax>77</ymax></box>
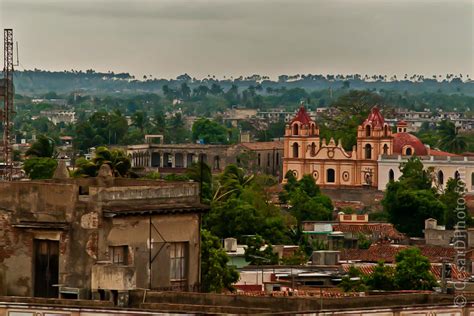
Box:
<box><xmin>332</xmin><ymin>223</ymin><xmax>405</xmax><ymax>240</ymax></box>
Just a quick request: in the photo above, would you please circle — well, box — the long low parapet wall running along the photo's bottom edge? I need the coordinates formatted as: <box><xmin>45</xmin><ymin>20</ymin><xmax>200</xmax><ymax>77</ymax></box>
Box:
<box><xmin>0</xmin><ymin>290</ymin><xmax>466</xmax><ymax>316</ymax></box>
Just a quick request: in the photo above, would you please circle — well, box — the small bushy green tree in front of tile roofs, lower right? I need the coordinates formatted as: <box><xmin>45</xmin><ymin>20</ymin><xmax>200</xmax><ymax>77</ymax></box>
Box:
<box><xmin>394</xmin><ymin>247</ymin><xmax>437</xmax><ymax>290</ymax></box>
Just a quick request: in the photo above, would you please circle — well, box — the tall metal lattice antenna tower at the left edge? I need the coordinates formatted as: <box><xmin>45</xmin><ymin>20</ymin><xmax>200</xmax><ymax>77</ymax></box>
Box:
<box><xmin>2</xmin><ymin>29</ymin><xmax>15</xmax><ymax>181</ymax></box>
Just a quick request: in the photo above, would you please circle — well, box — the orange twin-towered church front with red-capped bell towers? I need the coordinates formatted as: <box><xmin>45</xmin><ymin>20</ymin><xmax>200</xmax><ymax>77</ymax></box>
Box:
<box><xmin>283</xmin><ymin>106</ymin><xmax>393</xmax><ymax>187</ymax></box>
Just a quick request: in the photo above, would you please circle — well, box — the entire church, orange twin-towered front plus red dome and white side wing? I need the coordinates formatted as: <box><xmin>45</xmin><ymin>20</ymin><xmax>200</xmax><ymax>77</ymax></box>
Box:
<box><xmin>283</xmin><ymin>106</ymin><xmax>474</xmax><ymax>192</ymax></box>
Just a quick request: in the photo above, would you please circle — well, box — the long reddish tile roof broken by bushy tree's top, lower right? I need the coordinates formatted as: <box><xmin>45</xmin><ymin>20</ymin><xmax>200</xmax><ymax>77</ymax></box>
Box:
<box><xmin>341</xmin><ymin>244</ymin><xmax>456</xmax><ymax>263</ymax></box>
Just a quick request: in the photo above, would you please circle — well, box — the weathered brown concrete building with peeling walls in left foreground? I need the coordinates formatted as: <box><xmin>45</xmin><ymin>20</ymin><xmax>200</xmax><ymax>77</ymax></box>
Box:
<box><xmin>0</xmin><ymin>173</ymin><xmax>207</xmax><ymax>298</ymax></box>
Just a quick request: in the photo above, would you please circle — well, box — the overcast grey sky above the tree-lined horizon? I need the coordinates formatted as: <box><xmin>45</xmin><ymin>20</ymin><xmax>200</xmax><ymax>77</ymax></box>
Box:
<box><xmin>0</xmin><ymin>0</ymin><xmax>474</xmax><ymax>78</ymax></box>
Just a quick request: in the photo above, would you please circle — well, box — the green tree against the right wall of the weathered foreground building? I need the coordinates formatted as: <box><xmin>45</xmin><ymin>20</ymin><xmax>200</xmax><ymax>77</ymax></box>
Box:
<box><xmin>201</xmin><ymin>230</ymin><xmax>239</xmax><ymax>293</ymax></box>
